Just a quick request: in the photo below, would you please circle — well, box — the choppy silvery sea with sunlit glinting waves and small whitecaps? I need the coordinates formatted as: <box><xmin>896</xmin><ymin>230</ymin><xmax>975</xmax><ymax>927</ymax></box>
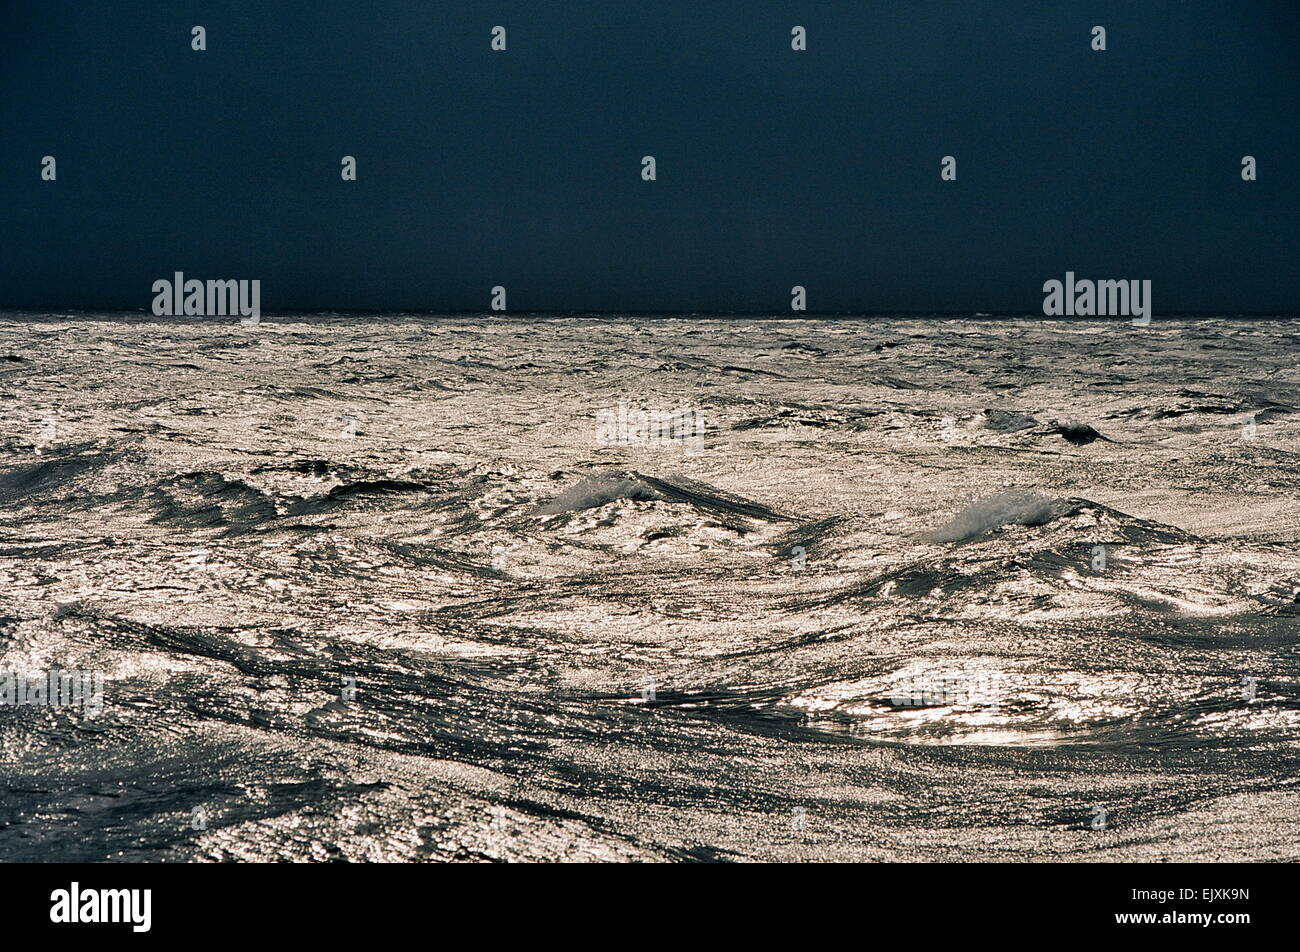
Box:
<box><xmin>0</xmin><ymin>313</ymin><xmax>1300</xmax><ymax>861</ymax></box>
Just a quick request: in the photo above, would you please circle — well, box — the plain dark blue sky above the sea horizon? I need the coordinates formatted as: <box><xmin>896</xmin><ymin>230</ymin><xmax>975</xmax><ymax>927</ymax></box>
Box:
<box><xmin>0</xmin><ymin>0</ymin><xmax>1300</xmax><ymax>315</ymax></box>
